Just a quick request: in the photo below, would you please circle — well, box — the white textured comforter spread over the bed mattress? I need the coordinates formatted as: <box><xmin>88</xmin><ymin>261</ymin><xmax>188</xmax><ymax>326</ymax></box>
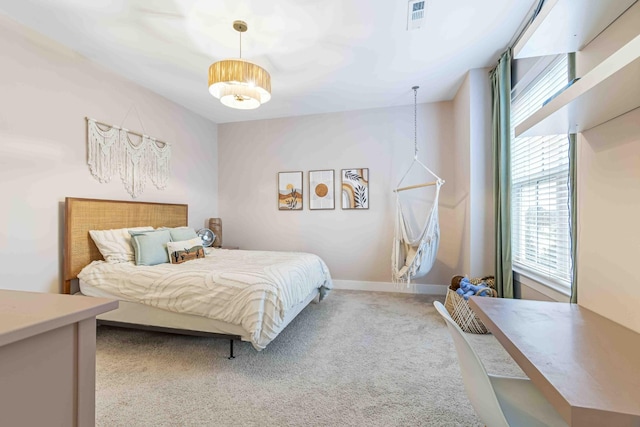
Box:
<box><xmin>78</xmin><ymin>249</ymin><xmax>332</xmax><ymax>350</ymax></box>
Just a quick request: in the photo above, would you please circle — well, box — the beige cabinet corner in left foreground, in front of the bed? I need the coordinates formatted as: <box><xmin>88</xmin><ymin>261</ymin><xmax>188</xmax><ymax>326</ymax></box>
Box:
<box><xmin>0</xmin><ymin>290</ymin><xmax>118</xmax><ymax>426</ymax></box>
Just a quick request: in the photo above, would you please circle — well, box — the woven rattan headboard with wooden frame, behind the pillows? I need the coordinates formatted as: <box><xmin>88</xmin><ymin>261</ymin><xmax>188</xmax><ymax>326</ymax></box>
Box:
<box><xmin>62</xmin><ymin>197</ymin><xmax>188</xmax><ymax>294</ymax></box>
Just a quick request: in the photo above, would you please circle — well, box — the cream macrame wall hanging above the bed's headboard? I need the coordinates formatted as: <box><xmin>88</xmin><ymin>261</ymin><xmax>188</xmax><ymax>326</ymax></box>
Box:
<box><xmin>87</xmin><ymin>113</ymin><xmax>171</xmax><ymax>199</ymax></box>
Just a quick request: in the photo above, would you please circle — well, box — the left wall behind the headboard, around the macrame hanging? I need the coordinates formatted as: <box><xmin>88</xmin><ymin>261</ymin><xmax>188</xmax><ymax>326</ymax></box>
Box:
<box><xmin>0</xmin><ymin>16</ymin><xmax>218</xmax><ymax>292</ymax></box>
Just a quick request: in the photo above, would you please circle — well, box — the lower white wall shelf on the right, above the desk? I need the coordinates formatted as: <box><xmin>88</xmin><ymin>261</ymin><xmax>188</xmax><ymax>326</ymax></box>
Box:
<box><xmin>515</xmin><ymin>35</ymin><xmax>640</xmax><ymax>137</ymax></box>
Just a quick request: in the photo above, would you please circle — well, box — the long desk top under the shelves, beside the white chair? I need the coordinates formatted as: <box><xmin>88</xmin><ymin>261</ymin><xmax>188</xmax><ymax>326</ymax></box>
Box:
<box><xmin>469</xmin><ymin>297</ymin><xmax>640</xmax><ymax>427</ymax></box>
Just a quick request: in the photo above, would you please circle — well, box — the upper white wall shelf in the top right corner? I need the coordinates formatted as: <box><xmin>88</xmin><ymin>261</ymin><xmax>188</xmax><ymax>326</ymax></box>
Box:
<box><xmin>513</xmin><ymin>0</ymin><xmax>636</xmax><ymax>59</ymax></box>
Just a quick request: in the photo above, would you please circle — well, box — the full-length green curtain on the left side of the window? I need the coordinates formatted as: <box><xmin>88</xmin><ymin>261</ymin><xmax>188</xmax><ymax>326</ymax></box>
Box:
<box><xmin>490</xmin><ymin>49</ymin><xmax>513</xmax><ymax>298</ymax></box>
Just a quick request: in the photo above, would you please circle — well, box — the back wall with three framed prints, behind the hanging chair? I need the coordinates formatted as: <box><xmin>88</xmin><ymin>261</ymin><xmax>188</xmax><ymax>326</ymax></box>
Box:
<box><xmin>218</xmin><ymin>102</ymin><xmax>463</xmax><ymax>285</ymax></box>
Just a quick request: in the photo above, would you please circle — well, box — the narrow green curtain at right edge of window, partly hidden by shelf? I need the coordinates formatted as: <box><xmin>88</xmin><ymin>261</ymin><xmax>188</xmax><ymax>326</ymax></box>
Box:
<box><xmin>567</xmin><ymin>53</ymin><xmax>578</xmax><ymax>304</ymax></box>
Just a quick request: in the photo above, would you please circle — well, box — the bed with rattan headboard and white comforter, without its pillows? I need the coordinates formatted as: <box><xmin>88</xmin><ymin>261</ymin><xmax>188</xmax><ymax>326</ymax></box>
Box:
<box><xmin>63</xmin><ymin>197</ymin><xmax>332</xmax><ymax>358</ymax></box>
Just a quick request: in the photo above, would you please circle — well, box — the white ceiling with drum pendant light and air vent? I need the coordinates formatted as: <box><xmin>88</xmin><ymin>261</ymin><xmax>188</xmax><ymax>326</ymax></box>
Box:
<box><xmin>0</xmin><ymin>0</ymin><xmax>537</xmax><ymax>123</ymax></box>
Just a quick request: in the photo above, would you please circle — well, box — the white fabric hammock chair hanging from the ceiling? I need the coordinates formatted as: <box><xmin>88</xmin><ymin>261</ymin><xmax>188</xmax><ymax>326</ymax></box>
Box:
<box><xmin>391</xmin><ymin>86</ymin><xmax>444</xmax><ymax>284</ymax></box>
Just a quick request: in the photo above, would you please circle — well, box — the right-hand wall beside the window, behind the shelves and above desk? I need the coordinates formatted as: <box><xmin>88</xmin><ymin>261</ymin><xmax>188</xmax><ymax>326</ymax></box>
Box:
<box><xmin>576</xmin><ymin>3</ymin><xmax>640</xmax><ymax>332</ymax></box>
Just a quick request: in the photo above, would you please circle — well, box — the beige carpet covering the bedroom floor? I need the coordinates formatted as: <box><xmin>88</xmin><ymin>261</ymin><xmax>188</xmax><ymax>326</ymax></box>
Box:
<box><xmin>96</xmin><ymin>291</ymin><xmax>523</xmax><ymax>427</ymax></box>
